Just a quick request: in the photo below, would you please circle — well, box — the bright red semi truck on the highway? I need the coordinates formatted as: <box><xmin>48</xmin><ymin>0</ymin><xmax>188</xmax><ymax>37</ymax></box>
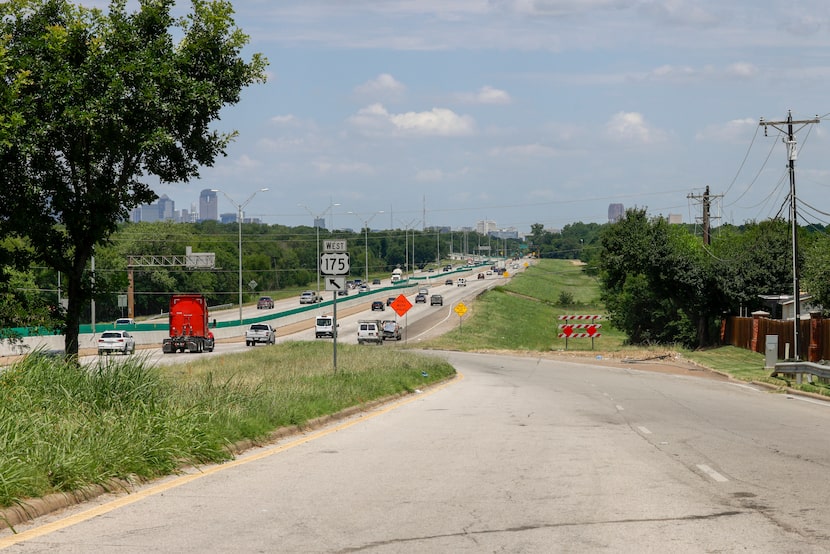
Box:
<box><xmin>161</xmin><ymin>294</ymin><xmax>214</xmax><ymax>354</ymax></box>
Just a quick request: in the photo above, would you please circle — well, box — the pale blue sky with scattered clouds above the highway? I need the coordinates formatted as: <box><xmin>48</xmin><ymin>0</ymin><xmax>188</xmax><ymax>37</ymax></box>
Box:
<box><xmin>81</xmin><ymin>0</ymin><xmax>830</xmax><ymax>233</ymax></box>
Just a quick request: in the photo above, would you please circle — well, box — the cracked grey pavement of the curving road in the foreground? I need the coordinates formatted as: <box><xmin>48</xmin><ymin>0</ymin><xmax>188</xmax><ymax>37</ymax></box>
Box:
<box><xmin>0</xmin><ymin>353</ymin><xmax>830</xmax><ymax>553</ymax></box>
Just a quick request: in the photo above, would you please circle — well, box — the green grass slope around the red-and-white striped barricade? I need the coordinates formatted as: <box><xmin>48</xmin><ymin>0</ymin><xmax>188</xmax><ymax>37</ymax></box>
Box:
<box><xmin>418</xmin><ymin>259</ymin><xmax>830</xmax><ymax>396</ymax></box>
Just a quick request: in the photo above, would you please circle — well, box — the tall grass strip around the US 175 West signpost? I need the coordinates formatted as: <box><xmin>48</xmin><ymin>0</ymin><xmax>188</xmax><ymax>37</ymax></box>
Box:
<box><xmin>0</xmin><ymin>342</ymin><xmax>454</xmax><ymax>507</ymax></box>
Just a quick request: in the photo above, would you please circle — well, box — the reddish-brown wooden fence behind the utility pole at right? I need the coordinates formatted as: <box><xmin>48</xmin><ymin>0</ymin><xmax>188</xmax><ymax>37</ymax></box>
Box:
<box><xmin>720</xmin><ymin>313</ymin><xmax>830</xmax><ymax>362</ymax></box>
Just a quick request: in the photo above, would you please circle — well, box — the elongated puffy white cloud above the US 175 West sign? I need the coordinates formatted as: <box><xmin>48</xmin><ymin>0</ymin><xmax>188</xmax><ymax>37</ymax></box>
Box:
<box><xmin>349</xmin><ymin>104</ymin><xmax>475</xmax><ymax>136</ymax></box>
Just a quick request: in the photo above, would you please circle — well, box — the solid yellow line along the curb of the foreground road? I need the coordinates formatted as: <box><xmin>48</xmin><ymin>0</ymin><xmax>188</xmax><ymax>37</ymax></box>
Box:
<box><xmin>0</xmin><ymin>373</ymin><xmax>464</xmax><ymax>550</ymax></box>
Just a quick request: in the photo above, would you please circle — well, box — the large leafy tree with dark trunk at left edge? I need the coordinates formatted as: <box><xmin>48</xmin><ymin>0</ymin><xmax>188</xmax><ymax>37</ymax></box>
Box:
<box><xmin>0</xmin><ymin>0</ymin><xmax>266</xmax><ymax>355</ymax></box>
